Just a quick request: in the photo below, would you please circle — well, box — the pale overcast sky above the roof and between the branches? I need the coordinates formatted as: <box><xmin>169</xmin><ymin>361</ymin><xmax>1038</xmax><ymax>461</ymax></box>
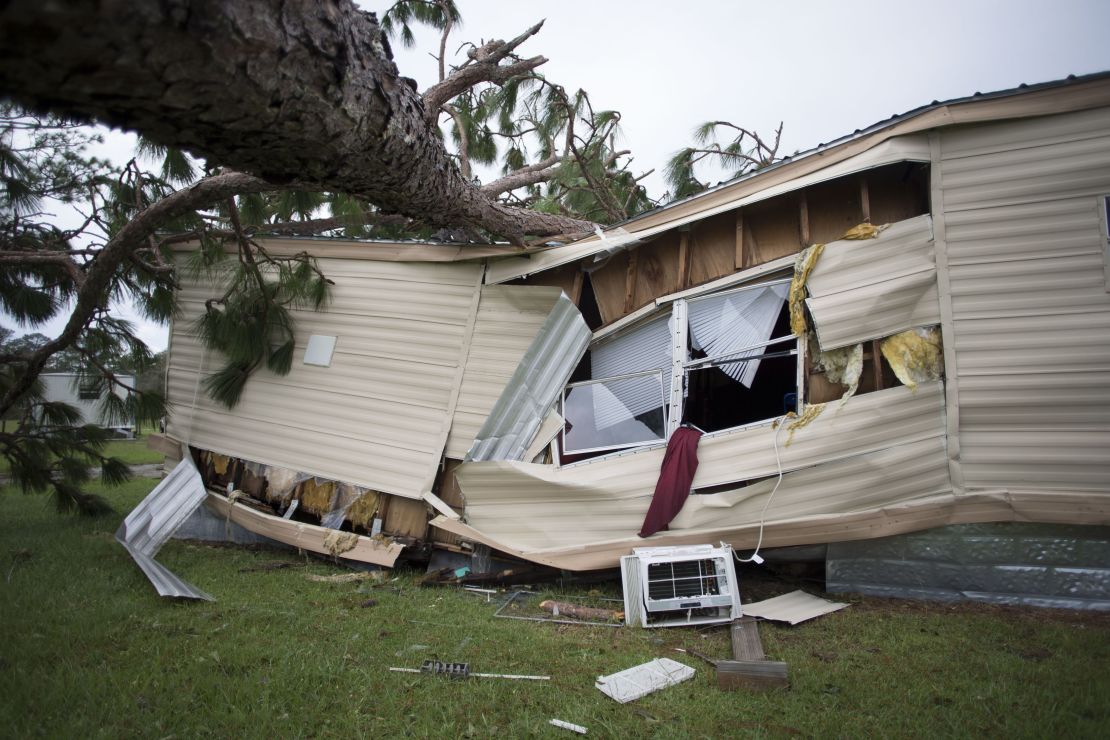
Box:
<box><xmin>4</xmin><ymin>0</ymin><xmax>1110</xmax><ymax>349</ymax></box>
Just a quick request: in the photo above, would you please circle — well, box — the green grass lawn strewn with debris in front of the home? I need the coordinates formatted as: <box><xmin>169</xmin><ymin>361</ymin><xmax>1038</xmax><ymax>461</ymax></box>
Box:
<box><xmin>0</xmin><ymin>479</ymin><xmax>1110</xmax><ymax>738</ymax></box>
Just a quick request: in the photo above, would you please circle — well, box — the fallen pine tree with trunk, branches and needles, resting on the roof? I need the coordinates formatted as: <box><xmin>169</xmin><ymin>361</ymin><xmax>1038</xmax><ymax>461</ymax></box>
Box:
<box><xmin>0</xmin><ymin>0</ymin><xmax>777</xmax><ymax>509</ymax></box>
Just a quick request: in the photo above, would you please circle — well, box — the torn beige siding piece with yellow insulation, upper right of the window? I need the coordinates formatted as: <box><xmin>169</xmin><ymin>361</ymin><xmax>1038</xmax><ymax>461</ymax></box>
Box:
<box><xmin>806</xmin><ymin>215</ymin><xmax>940</xmax><ymax>351</ymax></box>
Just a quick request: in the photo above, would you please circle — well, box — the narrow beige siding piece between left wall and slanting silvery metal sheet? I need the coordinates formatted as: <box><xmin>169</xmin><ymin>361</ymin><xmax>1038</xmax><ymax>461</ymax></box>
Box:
<box><xmin>446</xmin><ymin>285</ymin><xmax>563</xmax><ymax>459</ymax></box>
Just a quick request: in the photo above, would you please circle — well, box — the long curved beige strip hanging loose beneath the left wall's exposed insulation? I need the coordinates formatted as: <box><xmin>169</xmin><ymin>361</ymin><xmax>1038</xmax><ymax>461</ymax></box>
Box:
<box><xmin>205</xmin><ymin>491</ymin><xmax>404</xmax><ymax>568</ymax></box>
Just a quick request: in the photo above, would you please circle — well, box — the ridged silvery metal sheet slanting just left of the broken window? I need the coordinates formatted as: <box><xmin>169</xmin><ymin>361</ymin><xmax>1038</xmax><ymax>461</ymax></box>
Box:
<box><xmin>466</xmin><ymin>295</ymin><xmax>593</xmax><ymax>460</ymax></box>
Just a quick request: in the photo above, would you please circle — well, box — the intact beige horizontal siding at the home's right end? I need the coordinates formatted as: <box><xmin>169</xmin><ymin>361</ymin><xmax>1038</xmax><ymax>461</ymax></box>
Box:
<box><xmin>935</xmin><ymin>108</ymin><xmax>1110</xmax><ymax>493</ymax></box>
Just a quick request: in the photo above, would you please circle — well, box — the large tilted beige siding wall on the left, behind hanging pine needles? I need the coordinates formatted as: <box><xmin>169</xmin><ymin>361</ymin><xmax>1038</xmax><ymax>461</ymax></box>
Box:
<box><xmin>168</xmin><ymin>259</ymin><xmax>481</xmax><ymax>498</ymax></box>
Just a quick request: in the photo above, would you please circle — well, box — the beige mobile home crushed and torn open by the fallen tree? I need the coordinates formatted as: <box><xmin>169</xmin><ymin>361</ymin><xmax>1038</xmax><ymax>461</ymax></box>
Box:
<box><xmin>134</xmin><ymin>74</ymin><xmax>1110</xmax><ymax>603</ymax></box>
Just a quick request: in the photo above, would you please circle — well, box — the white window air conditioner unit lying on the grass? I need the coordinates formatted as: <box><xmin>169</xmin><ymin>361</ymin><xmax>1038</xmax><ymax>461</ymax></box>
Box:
<box><xmin>620</xmin><ymin>545</ymin><xmax>741</xmax><ymax>627</ymax></box>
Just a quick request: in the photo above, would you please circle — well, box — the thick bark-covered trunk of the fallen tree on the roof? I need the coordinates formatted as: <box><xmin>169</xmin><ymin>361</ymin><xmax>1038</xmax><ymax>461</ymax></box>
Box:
<box><xmin>0</xmin><ymin>0</ymin><xmax>592</xmax><ymax>243</ymax></box>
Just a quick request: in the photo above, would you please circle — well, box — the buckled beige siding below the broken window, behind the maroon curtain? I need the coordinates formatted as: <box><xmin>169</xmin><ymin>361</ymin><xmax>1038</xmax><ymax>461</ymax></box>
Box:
<box><xmin>456</xmin><ymin>383</ymin><xmax>948</xmax><ymax>550</ymax></box>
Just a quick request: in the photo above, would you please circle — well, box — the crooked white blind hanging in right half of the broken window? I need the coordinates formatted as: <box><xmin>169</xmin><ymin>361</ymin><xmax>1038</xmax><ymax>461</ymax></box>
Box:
<box><xmin>688</xmin><ymin>283</ymin><xmax>790</xmax><ymax>388</ymax></box>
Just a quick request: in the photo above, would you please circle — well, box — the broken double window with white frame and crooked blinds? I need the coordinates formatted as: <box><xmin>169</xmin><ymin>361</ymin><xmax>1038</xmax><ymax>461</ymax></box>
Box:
<box><xmin>563</xmin><ymin>280</ymin><xmax>799</xmax><ymax>463</ymax></box>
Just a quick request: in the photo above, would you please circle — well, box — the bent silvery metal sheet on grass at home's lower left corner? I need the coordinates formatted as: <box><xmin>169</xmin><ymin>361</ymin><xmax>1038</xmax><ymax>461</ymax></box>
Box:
<box><xmin>115</xmin><ymin>455</ymin><xmax>215</xmax><ymax>601</ymax></box>
